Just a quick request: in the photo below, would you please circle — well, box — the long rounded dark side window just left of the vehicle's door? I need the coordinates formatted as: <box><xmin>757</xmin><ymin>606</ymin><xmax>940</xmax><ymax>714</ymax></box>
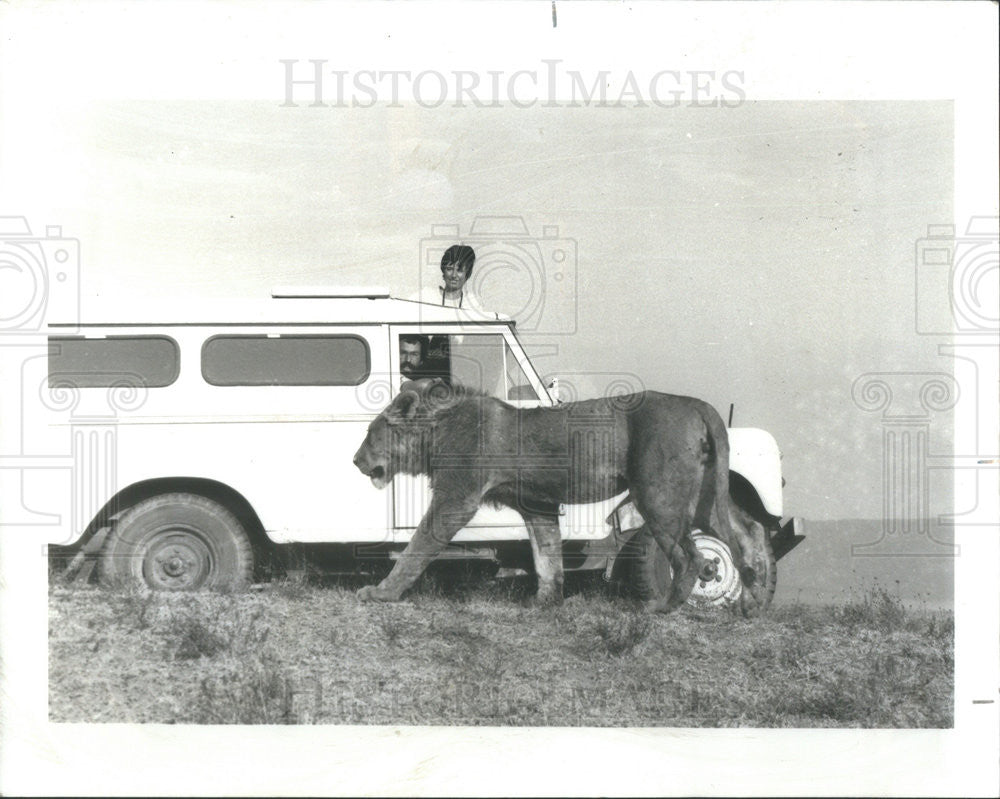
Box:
<box><xmin>201</xmin><ymin>335</ymin><xmax>371</xmax><ymax>386</ymax></box>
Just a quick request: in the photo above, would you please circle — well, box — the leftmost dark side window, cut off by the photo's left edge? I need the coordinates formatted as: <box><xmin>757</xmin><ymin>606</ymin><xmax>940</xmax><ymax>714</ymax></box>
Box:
<box><xmin>49</xmin><ymin>336</ymin><xmax>180</xmax><ymax>388</ymax></box>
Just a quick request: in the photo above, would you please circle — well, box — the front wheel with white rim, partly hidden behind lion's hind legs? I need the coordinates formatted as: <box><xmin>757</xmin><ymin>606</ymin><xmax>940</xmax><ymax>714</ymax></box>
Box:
<box><xmin>619</xmin><ymin>527</ymin><xmax>778</xmax><ymax>615</ymax></box>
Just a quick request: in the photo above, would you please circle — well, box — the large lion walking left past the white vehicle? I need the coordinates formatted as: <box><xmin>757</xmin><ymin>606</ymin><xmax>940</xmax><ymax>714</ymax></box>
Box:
<box><xmin>354</xmin><ymin>378</ymin><xmax>761</xmax><ymax>612</ymax></box>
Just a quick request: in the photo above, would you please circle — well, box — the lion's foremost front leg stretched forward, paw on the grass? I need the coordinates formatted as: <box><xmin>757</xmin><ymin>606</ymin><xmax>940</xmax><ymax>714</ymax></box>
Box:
<box><xmin>358</xmin><ymin>495</ymin><xmax>479</xmax><ymax>602</ymax></box>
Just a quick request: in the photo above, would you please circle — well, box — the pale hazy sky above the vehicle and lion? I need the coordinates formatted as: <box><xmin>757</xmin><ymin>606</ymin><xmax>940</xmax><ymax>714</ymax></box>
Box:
<box><xmin>15</xmin><ymin>100</ymin><xmax>954</xmax><ymax>519</ymax></box>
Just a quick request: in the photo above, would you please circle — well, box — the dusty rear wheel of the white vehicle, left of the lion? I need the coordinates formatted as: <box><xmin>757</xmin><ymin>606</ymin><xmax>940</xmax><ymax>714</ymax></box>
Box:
<box><xmin>100</xmin><ymin>493</ymin><xmax>253</xmax><ymax>591</ymax></box>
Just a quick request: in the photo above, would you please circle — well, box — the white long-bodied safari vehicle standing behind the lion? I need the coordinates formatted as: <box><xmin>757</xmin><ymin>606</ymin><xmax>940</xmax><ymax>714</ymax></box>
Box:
<box><xmin>41</xmin><ymin>289</ymin><xmax>801</xmax><ymax>605</ymax></box>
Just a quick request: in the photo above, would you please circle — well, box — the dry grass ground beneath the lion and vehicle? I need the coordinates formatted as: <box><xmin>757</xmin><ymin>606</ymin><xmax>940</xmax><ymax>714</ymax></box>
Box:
<box><xmin>49</xmin><ymin>581</ymin><xmax>954</xmax><ymax>727</ymax></box>
